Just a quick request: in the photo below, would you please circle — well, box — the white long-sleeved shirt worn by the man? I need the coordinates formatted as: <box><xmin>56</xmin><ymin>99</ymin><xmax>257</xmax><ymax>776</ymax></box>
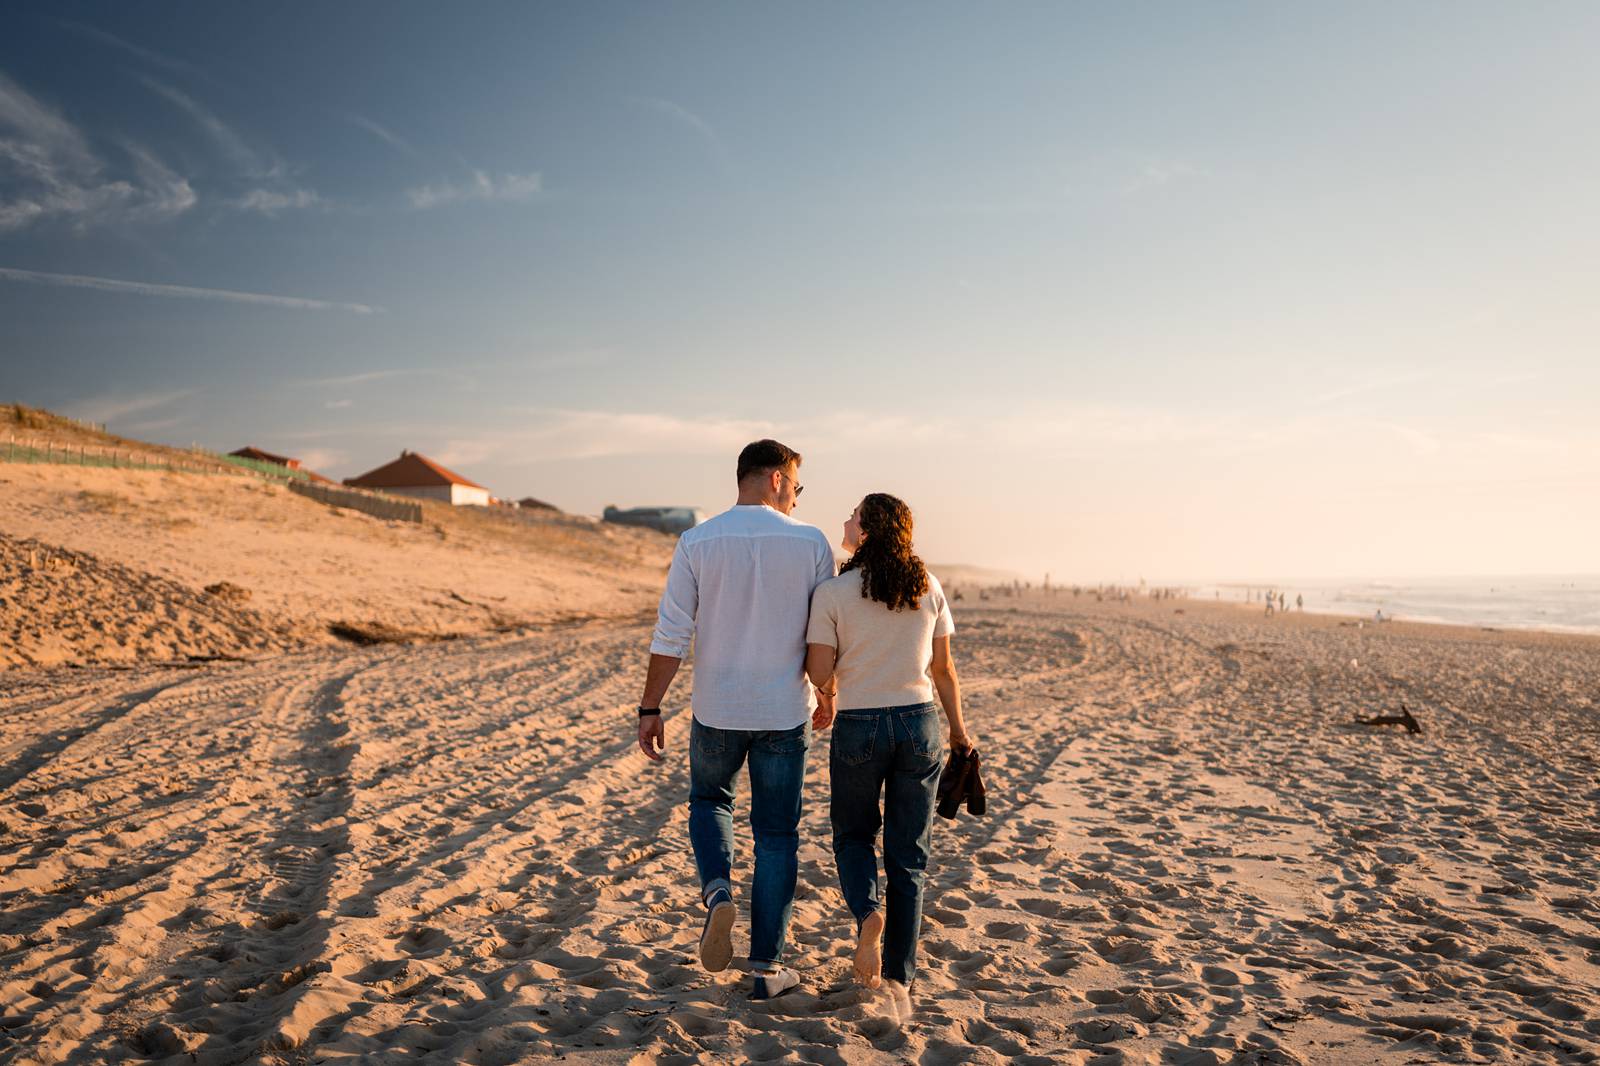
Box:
<box><xmin>650</xmin><ymin>504</ymin><xmax>834</xmax><ymax>730</ymax></box>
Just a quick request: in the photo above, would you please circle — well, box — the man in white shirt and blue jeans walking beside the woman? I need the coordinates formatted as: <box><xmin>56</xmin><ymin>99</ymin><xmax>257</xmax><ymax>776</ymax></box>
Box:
<box><xmin>638</xmin><ymin>440</ymin><xmax>834</xmax><ymax>999</ymax></box>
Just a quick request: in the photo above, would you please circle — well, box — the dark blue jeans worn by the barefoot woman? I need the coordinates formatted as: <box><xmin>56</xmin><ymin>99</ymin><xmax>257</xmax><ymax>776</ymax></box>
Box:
<box><xmin>829</xmin><ymin>703</ymin><xmax>944</xmax><ymax>986</ymax></box>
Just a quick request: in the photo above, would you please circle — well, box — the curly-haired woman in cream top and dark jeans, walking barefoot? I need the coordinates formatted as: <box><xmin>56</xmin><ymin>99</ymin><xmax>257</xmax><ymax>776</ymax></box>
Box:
<box><xmin>805</xmin><ymin>493</ymin><xmax>970</xmax><ymax>1010</ymax></box>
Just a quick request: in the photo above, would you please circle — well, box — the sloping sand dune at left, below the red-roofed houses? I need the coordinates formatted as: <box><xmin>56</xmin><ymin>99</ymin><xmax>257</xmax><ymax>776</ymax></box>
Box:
<box><xmin>0</xmin><ymin>463</ymin><xmax>672</xmax><ymax>669</ymax></box>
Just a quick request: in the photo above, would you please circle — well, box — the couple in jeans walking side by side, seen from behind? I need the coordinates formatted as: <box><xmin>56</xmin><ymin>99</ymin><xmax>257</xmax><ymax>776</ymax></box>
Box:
<box><xmin>638</xmin><ymin>440</ymin><xmax>971</xmax><ymax>1015</ymax></box>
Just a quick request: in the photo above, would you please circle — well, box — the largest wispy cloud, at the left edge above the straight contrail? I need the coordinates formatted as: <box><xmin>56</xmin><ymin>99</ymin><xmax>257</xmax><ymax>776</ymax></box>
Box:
<box><xmin>0</xmin><ymin>74</ymin><xmax>198</xmax><ymax>232</ymax></box>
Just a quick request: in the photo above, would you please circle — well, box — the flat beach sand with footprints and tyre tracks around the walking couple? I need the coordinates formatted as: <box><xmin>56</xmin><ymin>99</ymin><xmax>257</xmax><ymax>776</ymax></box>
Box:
<box><xmin>0</xmin><ymin>589</ymin><xmax>1600</xmax><ymax>1064</ymax></box>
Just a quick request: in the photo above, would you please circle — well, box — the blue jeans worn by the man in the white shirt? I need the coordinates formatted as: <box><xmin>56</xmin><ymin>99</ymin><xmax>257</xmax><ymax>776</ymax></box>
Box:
<box><xmin>690</xmin><ymin>720</ymin><xmax>811</xmax><ymax>964</ymax></box>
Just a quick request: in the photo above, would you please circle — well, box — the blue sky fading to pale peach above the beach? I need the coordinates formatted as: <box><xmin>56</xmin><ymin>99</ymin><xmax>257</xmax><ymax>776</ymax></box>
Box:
<box><xmin>0</xmin><ymin>0</ymin><xmax>1600</xmax><ymax>583</ymax></box>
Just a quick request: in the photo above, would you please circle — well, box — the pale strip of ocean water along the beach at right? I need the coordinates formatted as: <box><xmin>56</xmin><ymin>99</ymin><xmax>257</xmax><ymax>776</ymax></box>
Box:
<box><xmin>1189</xmin><ymin>575</ymin><xmax>1600</xmax><ymax>634</ymax></box>
